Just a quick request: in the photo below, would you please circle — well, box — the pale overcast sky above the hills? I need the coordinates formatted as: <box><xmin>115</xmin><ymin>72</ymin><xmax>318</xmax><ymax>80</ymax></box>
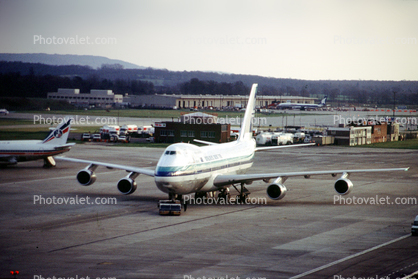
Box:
<box><xmin>0</xmin><ymin>0</ymin><xmax>418</xmax><ymax>80</ymax></box>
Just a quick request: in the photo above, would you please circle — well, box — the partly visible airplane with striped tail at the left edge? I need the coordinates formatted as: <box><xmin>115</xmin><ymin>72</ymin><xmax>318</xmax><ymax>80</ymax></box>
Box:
<box><xmin>0</xmin><ymin>119</ymin><xmax>75</xmax><ymax>167</ymax></box>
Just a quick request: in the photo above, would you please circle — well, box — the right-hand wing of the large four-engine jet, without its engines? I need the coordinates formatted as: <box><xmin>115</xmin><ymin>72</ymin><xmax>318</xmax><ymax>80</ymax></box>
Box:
<box><xmin>213</xmin><ymin>168</ymin><xmax>409</xmax><ymax>188</ymax></box>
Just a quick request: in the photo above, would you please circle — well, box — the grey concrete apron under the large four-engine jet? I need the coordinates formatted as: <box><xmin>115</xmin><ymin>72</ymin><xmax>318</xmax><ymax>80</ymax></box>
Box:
<box><xmin>0</xmin><ymin>143</ymin><xmax>418</xmax><ymax>279</ymax></box>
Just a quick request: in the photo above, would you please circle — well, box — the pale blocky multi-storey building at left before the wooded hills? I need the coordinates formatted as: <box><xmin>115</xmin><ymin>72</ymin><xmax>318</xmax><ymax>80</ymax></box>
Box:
<box><xmin>47</xmin><ymin>88</ymin><xmax>123</xmax><ymax>107</ymax></box>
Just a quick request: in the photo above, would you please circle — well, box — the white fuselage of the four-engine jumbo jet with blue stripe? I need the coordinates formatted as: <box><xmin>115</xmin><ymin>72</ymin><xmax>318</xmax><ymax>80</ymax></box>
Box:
<box><xmin>155</xmin><ymin>139</ymin><xmax>255</xmax><ymax>195</ymax></box>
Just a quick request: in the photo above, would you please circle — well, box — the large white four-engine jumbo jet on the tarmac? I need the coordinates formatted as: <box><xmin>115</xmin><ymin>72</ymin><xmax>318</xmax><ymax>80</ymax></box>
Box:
<box><xmin>57</xmin><ymin>84</ymin><xmax>408</xmax><ymax>213</ymax></box>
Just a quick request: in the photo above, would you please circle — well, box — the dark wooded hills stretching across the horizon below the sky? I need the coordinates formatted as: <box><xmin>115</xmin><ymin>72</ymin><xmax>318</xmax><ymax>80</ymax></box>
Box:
<box><xmin>0</xmin><ymin>61</ymin><xmax>418</xmax><ymax>106</ymax></box>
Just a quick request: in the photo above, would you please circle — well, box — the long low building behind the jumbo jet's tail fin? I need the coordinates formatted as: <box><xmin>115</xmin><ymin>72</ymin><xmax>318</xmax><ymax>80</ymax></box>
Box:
<box><xmin>123</xmin><ymin>94</ymin><xmax>315</xmax><ymax>108</ymax></box>
